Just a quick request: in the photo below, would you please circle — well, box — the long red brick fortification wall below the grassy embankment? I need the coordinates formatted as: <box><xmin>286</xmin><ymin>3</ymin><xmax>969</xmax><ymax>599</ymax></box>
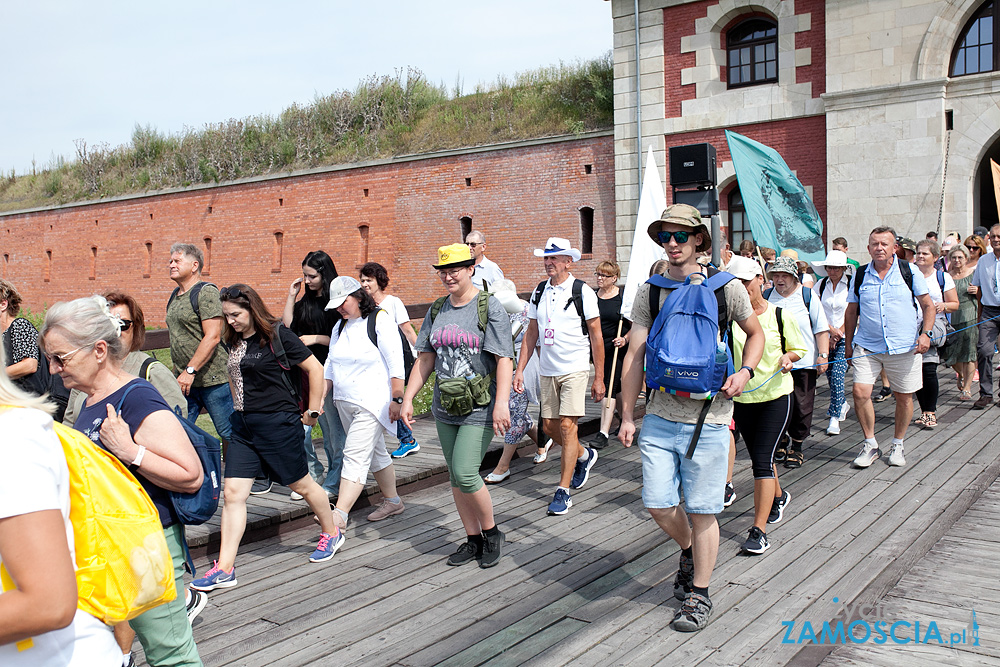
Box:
<box><xmin>0</xmin><ymin>136</ymin><xmax>615</xmax><ymax>324</ymax></box>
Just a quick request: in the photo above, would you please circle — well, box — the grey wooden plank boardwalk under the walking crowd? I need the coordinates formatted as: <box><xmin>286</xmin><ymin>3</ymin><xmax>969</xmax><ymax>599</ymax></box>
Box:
<box><xmin>137</xmin><ymin>371</ymin><xmax>1000</xmax><ymax>667</ymax></box>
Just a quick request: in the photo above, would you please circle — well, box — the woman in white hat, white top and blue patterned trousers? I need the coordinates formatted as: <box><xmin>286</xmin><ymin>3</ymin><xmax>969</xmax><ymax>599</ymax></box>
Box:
<box><xmin>812</xmin><ymin>250</ymin><xmax>851</xmax><ymax>435</ymax></box>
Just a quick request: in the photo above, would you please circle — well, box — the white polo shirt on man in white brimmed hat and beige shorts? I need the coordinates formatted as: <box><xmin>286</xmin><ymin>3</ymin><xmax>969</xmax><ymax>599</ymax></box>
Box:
<box><xmin>528</xmin><ymin>274</ymin><xmax>601</xmax><ymax>377</ymax></box>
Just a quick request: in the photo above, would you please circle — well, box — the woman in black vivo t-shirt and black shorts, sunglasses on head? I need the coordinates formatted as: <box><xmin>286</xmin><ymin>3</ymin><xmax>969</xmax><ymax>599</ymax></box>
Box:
<box><xmin>191</xmin><ymin>283</ymin><xmax>344</xmax><ymax>591</ymax></box>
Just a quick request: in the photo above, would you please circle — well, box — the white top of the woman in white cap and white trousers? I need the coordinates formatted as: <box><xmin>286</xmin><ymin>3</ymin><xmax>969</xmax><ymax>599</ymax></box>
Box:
<box><xmin>323</xmin><ymin>311</ymin><xmax>403</xmax><ymax>433</ymax></box>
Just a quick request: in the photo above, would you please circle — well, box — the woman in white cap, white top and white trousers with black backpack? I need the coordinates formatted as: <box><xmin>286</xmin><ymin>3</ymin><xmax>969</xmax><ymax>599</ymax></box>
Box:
<box><xmin>324</xmin><ymin>276</ymin><xmax>404</xmax><ymax>531</ymax></box>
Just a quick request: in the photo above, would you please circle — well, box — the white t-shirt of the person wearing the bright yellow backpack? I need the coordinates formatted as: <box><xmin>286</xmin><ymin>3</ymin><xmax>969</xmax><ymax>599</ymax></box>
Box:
<box><xmin>0</xmin><ymin>408</ymin><xmax>122</xmax><ymax>667</ymax></box>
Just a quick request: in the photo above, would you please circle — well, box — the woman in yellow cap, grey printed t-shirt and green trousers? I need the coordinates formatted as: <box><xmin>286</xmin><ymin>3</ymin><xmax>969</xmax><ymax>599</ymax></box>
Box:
<box><xmin>402</xmin><ymin>243</ymin><xmax>514</xmax><ymax>568</ymax></box>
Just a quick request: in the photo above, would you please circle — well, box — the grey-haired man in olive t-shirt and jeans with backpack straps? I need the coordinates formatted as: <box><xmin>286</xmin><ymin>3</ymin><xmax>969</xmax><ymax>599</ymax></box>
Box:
<box><xmin>166</xmin><ymin>243</ymin><xmax>246</xmax><ymax>490</ymax></box>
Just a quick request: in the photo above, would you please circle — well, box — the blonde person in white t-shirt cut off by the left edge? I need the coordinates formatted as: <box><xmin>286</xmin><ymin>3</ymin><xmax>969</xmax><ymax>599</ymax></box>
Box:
<box><xmin>0</xmin><ymin>358</ymin><xmax>122</xmax><ymax>667</ymax></box>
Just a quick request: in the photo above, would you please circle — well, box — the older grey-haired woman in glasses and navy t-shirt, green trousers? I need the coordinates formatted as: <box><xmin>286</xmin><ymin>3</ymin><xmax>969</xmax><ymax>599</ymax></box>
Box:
<box><xmin>41</xmin><ymin>296</ymin><xmax>205</xmax><ymax>665</ymax></box>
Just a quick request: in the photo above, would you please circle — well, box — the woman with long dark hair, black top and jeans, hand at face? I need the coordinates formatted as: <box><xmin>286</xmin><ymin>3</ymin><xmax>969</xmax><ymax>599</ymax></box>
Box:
<box><xmin>281</xmin><ymin>250</ymin><xmax>347</xmax><ymax>500</ymax></box>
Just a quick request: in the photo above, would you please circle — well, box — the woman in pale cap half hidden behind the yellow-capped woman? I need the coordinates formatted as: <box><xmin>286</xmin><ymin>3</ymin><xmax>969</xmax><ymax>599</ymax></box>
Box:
<box><xmin>483</xmin><ymin>278</ymin><xmax>548</xmax><ymax>484</ymax></box>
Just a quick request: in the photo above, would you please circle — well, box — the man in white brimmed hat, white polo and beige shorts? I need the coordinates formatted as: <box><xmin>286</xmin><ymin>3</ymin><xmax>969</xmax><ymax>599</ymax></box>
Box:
<box><xmin>514</xmin><ymin>237</ymin><xmax>604</xmax><ymax>515</ymax></box>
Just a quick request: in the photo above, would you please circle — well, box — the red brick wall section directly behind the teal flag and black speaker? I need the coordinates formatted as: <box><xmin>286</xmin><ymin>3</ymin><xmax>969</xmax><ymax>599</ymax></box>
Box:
<box><xmin>666</xmin><ymin>116</ymin><xmax>826</xmax><ymax>224</ymax></box>
